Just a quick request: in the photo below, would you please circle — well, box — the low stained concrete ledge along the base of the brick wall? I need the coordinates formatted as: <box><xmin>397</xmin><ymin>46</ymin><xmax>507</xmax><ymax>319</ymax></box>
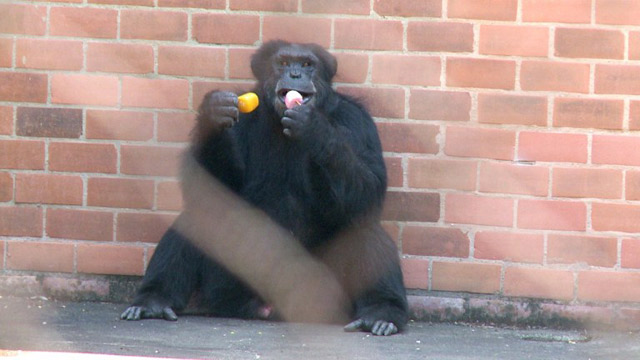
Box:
<box><xmin>0</xmin><ymin>274</ymin><xmax>640</xmax><ymax>330</ymax></box>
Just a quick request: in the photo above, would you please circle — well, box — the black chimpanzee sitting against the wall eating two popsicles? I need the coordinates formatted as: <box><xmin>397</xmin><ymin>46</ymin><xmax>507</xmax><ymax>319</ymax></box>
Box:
<box><xmin>121</xmin><ymin>40</ymin><xmax>408</xmax><ymax>335</ymax></box>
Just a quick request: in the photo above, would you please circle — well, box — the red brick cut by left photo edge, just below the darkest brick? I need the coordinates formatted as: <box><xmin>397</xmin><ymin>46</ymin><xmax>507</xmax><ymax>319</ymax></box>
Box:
<box><xmin>0</xmin><ymin>140</ymin><xmax>44</xmax><ymax>170</ymax></box>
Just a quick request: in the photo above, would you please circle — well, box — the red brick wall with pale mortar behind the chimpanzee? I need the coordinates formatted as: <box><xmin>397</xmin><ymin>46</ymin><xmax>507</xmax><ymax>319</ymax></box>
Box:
<box><xmin>0</xmin><ymin>0</ymin><xmax>640</xmax><ymax>324</ymax></box>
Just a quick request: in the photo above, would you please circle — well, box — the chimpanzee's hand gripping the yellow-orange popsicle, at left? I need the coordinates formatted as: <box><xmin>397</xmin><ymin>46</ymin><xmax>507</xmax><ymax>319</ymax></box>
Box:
<box><xmin>199</xmin><ymin>91</ymin><xmax>238</xmax><ymax>132</ymax></box>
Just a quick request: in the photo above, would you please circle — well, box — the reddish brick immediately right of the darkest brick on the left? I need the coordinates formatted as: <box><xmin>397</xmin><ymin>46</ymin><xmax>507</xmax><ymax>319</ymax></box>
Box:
<box><xmin>85</xmin><ymin>109</ymin><xmax>153</xmax><ymax>141</ymax></box>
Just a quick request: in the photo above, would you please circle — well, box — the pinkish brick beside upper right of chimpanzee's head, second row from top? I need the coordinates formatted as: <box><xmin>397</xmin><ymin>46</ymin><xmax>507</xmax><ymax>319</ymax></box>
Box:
<box><xmin>332</xmin><ymin>18</ymin><xmax>404</xmax><ymax>50</ymax></box>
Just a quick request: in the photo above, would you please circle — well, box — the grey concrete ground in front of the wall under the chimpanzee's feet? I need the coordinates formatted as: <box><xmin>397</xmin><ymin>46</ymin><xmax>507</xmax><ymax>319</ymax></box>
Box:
<box><xmin>0</xmin><ymin>297</ymin><xmax>640</xmax><ymax>360</ymax></box>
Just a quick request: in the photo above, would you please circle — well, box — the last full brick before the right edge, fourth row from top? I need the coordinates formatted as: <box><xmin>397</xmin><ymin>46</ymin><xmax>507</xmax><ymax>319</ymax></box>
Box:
<box><xmin>553</xmin><ymin>98</ymin><xmax>624</xmax><ymax>130</ymax></box>
